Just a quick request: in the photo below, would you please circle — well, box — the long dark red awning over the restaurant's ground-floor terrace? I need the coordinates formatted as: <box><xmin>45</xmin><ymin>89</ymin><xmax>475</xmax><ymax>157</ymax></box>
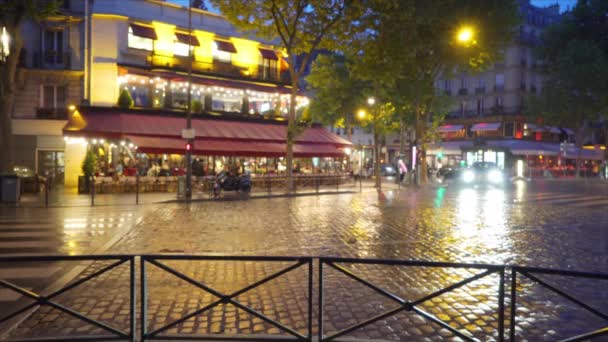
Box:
<box><xmin>63</xmin><ymin>108</ymin><xmax>352</xmax><ymax>157</ymax></box>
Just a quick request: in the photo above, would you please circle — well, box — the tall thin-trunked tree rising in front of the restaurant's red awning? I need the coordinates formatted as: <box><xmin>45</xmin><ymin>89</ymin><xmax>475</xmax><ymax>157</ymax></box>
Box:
<box><xmin>211</xmin><ymin>0</ymin><xmax>355</xmax><ymax>192</ymax></box>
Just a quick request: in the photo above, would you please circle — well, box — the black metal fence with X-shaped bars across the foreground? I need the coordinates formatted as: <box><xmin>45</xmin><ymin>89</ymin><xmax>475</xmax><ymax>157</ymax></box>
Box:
<box><xmin>0</xmin><ymin>255</ymin><xmax>608</xmax><ymax>341</ymax></box>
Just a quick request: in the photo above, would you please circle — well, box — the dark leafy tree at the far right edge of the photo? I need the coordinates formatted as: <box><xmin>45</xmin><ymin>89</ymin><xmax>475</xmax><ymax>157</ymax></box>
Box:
<box><xmin>527</xmin><ymin>0</ymin><xmax>608</xmax><ymax>176</ymax></box>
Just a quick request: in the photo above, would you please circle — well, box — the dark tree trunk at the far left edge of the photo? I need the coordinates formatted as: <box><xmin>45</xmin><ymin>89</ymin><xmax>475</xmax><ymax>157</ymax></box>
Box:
<box><xmin>0</xmin><ymin>23</ymin><xmax>23</xmax><ymax>172</ymax></box>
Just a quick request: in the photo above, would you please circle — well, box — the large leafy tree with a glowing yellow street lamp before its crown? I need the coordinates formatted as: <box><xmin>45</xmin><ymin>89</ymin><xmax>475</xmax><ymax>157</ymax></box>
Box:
<box><xmin>349</xmin><ymin>0</ymin><xmax>518</xmax><ymax>184</ymax></box>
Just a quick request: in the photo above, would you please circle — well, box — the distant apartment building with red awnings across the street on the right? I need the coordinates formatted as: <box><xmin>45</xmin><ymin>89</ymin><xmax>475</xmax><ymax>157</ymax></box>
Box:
<box><xmin>427</xmin><ymin>0</ymin><xmax>603</xmax><ymax>171</ymax></box>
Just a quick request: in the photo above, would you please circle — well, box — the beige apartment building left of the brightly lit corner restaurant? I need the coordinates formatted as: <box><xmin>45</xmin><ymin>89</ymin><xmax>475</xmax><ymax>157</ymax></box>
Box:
<box><xmin>12</xmin><ymin>0</ymin><xmax>85</xmax><ymax>187</ymax></box>
